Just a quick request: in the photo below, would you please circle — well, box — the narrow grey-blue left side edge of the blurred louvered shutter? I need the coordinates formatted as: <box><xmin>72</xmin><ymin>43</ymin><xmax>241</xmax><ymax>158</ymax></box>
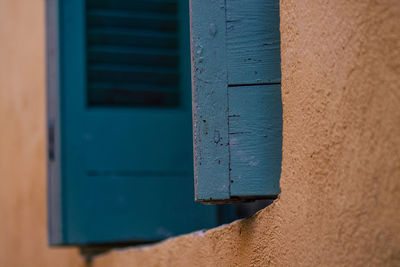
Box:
<box><xmin>46</xmin><ymin>0</ymin><xmax>63</xmax><ymax>245</ymax></box>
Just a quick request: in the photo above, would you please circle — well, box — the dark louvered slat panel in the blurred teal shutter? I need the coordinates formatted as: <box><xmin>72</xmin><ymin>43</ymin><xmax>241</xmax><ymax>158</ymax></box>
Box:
<box><xmin>86</xmin><ymin>0</ymin><xmax>179</xmax><ymax>106</ymax></box>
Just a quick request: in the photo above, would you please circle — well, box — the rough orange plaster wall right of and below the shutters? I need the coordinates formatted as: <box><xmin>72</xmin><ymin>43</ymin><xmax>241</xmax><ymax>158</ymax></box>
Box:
<box><xmin>94</xmin><ymin>0</ymin><xmax>400</xmax><ymax>267</ymax></box>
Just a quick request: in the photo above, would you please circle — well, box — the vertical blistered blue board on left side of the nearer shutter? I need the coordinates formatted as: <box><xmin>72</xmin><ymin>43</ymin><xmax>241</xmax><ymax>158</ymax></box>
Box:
<box><xmin>190</xmin><ymin>0</ymin><xmax>229</xmax><ymax>201</ymax></box>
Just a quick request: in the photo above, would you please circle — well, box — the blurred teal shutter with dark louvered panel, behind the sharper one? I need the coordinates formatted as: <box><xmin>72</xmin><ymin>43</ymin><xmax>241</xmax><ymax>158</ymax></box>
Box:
<box><xmin>47</xmin><ymin>0</ymin><xmax>222</xmax><ymax>245</ymax></box>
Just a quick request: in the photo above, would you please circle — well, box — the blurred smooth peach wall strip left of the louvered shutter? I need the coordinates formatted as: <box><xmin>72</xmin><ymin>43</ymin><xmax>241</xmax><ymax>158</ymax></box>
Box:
<box><xmin>0</xmin><ymin>0</ymin><xmax>81</xmax><ymax>267</ymax></box>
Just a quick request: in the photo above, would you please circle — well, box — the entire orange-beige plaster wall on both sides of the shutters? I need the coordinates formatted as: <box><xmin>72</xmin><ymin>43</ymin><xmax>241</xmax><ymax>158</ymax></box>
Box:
<box><xmin>0</xmin><ymin>0</ymin><xmax>400</xmax><ymax>267</ymax></box>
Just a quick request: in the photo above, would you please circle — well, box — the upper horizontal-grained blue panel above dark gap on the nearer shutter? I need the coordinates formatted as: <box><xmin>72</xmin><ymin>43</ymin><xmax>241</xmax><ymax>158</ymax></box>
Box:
<box><xmin>227</xmin><ymin>0</ymin><xmax>281</xmax><ymax>84</ymax></box>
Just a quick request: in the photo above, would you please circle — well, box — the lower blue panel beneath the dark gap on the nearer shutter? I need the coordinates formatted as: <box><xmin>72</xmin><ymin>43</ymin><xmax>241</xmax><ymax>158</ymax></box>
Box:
<box><xmin>229</xmin><ymin>84</ymin><xmax>282</xmax><ymax>197</ymax></box>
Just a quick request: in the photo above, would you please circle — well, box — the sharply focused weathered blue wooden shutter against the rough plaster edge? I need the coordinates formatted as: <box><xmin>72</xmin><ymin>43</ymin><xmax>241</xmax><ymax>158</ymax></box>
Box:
<box><xmin>190</xmin><ymin>0</ymin><xmax>282</xmax><ymax>203</ymax></box>
